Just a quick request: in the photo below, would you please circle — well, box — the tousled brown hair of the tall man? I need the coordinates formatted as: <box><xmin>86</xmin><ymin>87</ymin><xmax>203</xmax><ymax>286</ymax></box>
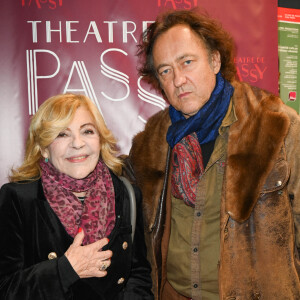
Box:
<box><xmin>137</xmin><ymin>8</ymin><xmax>236</xmax><ymax>91</ymax></box>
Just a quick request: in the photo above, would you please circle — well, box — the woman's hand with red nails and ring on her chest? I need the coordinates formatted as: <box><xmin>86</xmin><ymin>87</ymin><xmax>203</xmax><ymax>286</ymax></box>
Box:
<box><xmin>65</xmin><ymin>230</ymin><xmax>112</xmax><ymax>278</ymax></box>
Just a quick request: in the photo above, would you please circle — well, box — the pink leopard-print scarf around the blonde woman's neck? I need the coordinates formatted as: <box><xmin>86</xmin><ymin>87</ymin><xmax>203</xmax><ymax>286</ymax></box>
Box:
<box><xmin>40</xmin><ymin>160</ymin><xmax>115</xmax><ymax>245</ymax></box>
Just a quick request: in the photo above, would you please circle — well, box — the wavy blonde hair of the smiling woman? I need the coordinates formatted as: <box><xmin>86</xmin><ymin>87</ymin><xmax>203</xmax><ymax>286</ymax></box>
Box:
<box><xmin>9</xmin><ymin>94</ymin><xmax>122</xmax><ymax>182</ymax></box>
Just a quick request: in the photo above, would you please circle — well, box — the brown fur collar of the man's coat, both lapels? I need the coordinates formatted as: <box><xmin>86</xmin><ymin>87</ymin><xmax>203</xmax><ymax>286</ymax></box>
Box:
<box><xmin>130</xmin><ymin>82</ymin><xmax>290</xmax><ymax>230</ymax></box>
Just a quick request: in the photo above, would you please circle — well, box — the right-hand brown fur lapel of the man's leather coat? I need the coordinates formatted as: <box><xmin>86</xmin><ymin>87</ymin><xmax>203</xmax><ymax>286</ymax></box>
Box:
<box><xmin>225</xmin><ymin>83</ymin><xmax>290</xmax><ymax>222</ymax></box>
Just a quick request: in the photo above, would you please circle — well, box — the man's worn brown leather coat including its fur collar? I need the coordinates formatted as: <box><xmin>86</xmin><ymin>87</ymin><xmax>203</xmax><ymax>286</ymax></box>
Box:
<box><xmin>129</xmin><ymin>82</ymin><xmax>300</xmax><ymax>300</ymax></box>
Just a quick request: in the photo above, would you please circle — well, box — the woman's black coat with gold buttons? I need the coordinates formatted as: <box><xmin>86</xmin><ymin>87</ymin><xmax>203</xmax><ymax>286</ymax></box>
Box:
<box><xmin>0</xmin><ymin>174</ymin><xmax>153</xmax><ymax>300</ymax></box>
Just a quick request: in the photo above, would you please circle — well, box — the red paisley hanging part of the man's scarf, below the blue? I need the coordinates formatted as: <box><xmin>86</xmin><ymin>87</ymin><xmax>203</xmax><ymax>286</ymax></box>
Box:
<box><xmin>171</xmin><ymin>133</ymin><xmax>204</xmax><ymax>207</ymax></box>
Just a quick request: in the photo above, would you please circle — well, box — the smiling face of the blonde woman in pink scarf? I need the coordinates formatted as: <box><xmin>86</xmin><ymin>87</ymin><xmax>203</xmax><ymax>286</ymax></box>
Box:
<box><xmin>42</xmin><ymin>107</ymin><xmax>100</xmax><ymax>179</ymax></box>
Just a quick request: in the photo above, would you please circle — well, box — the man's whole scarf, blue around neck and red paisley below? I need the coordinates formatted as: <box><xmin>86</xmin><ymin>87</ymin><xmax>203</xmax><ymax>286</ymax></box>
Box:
<box><xmin>167</xmin><ymin>72</ymin><xmax>234</xmax><ymax>207</ymax></box>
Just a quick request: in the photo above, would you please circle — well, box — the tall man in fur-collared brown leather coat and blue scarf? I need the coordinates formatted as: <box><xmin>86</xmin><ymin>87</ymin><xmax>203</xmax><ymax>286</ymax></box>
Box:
<box><xmin>129</xmin><ymin>11</ymin><xmax>300</xmax><ymax>300</ymax></box>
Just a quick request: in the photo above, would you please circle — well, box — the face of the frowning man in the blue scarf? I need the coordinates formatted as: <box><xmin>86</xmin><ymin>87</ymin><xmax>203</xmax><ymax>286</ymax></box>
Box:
<box><xmin>153</xmin><ymin>25</ymin><xmax>221</xmax><ymax>118</ymax></box>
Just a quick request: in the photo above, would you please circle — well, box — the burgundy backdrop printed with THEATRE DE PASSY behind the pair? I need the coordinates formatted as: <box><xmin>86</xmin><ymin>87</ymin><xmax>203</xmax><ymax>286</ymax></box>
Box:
<box><xmin>0</xmin><ymin>0</ymin><xmax>278</xmax><ymax>184</ymax></box>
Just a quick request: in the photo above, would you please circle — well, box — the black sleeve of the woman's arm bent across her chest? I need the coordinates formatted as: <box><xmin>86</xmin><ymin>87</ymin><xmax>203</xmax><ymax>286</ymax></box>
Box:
<box><xmin>0</xmin><ymin>184</ymin><xmax>78</xmax><ymax>300</ymax></box>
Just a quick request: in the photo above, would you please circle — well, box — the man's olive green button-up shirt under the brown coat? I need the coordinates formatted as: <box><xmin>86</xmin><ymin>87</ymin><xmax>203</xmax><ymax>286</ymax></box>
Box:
<box><xmin>167</xmin><ymin>102</ymin><xmax>236</xmax><ymax>300</ymax></box>
